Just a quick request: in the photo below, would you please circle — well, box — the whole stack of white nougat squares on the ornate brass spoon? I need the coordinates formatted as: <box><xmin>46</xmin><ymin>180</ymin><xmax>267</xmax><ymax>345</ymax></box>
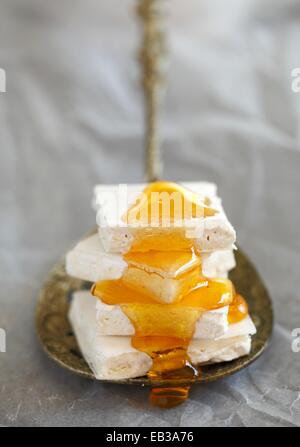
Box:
<box><xmin>66</xmin><ymin>182</ymin><xmax>256</xmax><ymax>380</ymax></box>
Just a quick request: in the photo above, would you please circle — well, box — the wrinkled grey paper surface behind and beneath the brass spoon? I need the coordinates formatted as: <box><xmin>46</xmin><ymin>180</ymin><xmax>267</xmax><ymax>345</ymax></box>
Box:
<box><xmin>0</xmin><ymin>0</ymin><xmax>300</xmax><ymax>426</ymax></box>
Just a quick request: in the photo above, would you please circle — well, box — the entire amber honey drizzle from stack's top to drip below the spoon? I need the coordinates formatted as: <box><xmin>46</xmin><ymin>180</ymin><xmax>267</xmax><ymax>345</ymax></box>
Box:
<box><xmin>92</xmin><ymin>182</ymin><xmax>248</xmax><ymax>408</ymax></box>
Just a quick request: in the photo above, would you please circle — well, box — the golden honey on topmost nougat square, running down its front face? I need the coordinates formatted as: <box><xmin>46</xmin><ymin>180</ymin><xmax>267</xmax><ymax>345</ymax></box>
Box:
<box><xmin>123</xmin><ymin>182</ymin><xmax>217</xmax><ymax>252</ymax></box>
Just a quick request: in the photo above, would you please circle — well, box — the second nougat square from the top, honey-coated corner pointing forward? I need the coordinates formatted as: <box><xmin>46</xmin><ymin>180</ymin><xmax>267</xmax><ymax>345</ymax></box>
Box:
<box><xmin>66</xmin><ymin>234</ymin><xmax>235</xmax><ymax>303</ymax></box>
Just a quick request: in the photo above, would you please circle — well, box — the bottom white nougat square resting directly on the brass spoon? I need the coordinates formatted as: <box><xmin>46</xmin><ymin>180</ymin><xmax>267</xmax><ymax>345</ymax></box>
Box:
<box><xmin>69</xmin><ymin>294</ymin><xmax>256</xmax><ymax>380</ymax></box>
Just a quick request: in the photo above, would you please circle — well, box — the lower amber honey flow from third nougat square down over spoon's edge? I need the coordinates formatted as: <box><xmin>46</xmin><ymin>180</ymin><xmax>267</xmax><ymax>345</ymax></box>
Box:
<box><xmin>92</xmin><ymin>279</ymin><xmax>248</xmax><ymax>408</ymax></box>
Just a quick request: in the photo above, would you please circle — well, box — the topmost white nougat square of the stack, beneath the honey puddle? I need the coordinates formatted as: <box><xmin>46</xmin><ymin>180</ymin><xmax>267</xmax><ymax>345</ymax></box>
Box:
<box><xmin>93</xmin><ymin>182</ymin><xmax>236</xmax><ymax>253</ymax></box>
